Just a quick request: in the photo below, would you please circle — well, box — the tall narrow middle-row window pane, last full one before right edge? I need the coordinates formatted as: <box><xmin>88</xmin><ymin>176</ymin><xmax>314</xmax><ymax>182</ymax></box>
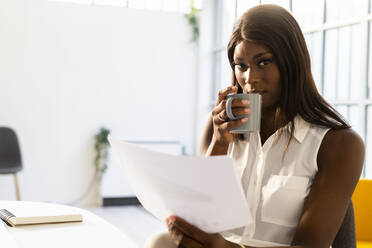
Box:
<box><xmin>350</xmin><ymin>24</ymin><xmax>366</xmax><ymax>99</ymax></box>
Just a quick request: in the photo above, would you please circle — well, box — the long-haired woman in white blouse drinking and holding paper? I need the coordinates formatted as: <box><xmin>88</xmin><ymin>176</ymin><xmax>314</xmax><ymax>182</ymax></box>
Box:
<box><xmin>144</xmin><ymin>5</ymin><xmax>364</xmax><ymax>248</ymax></box>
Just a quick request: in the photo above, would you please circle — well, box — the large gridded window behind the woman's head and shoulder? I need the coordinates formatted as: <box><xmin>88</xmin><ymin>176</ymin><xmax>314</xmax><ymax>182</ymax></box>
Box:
<box><xmin>211</xmin><ymin>0</ymin><xmax>372</xmax><ymax>178</ymax></box>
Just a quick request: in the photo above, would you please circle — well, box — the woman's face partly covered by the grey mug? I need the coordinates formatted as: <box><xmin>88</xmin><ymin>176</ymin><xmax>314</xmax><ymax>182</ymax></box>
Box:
<box><xmin>234</xmin><ymin>41</ymin><xmax>281</xmax><ymax>109</ymax></box>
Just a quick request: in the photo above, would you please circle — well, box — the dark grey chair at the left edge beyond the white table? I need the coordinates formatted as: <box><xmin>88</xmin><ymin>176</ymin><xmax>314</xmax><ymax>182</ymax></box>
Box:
<box><xmin>0</xmin><ymin>127</ymin><xmax>22</xmax><ymax>200</ymax></box>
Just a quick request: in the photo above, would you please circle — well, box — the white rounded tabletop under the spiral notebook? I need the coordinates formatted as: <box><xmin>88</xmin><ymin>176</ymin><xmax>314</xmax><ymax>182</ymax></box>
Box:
<box><xmin>0</xmin><ymin>201</ymin><xmax>138</xmax><ymax>248</ymax></box>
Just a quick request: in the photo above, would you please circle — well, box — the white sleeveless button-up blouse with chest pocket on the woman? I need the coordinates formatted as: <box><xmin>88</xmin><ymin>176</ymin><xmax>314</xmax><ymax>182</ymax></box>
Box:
<box><xmin>222</xmin><ymin>116</ymin><xmax>329</xmax><ymax>247</ymax></box>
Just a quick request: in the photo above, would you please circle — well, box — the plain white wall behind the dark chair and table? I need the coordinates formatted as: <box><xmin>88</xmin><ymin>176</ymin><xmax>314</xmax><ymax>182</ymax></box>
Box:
<box><xmin>0</xmin><ymin>0</ymin><xmax>196</xmax><ymax>203</ymax></box>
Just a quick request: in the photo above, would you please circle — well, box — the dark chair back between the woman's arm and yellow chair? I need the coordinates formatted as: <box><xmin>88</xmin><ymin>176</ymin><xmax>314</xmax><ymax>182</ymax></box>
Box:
<box><xmin>332</xmin><ymin>201</ymin><xmax>356</xmax><ymax>248</ymax></box>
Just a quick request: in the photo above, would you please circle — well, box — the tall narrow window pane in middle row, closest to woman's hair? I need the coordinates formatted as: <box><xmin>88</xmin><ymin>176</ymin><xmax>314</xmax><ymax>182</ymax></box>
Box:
<box><xmin>323</xmin><ymin>29</ymin><xmax>338</xmax><ymax>100</ymax></box>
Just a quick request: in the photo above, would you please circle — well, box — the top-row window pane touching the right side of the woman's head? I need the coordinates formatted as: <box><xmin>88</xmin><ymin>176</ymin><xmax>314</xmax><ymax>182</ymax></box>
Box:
<box><xmin>292</xmin><ymin>0</ymin><xmax>324</xmax><ymax>28</ymax></box>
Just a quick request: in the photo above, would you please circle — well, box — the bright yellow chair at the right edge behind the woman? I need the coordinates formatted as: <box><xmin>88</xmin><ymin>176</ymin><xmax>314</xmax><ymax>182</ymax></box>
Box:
<box><xmin>352</xmin><ymin>179</ymin><xmax>372</xmax><ymax>248</ymax></box>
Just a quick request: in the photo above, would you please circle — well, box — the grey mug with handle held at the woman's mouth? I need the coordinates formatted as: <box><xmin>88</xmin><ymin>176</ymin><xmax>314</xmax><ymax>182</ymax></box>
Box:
<box><xmin>226</xmin><ymin>93</ymin><xmax>262</xmax><ymax>133</ymax></box>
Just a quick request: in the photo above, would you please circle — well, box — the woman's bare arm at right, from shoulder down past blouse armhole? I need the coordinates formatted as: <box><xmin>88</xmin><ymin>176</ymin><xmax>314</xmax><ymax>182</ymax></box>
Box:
<box><xmin>292</xmin><ymin>129</ymin><xmax>365</xmax><ymax>248</ymax></box>
